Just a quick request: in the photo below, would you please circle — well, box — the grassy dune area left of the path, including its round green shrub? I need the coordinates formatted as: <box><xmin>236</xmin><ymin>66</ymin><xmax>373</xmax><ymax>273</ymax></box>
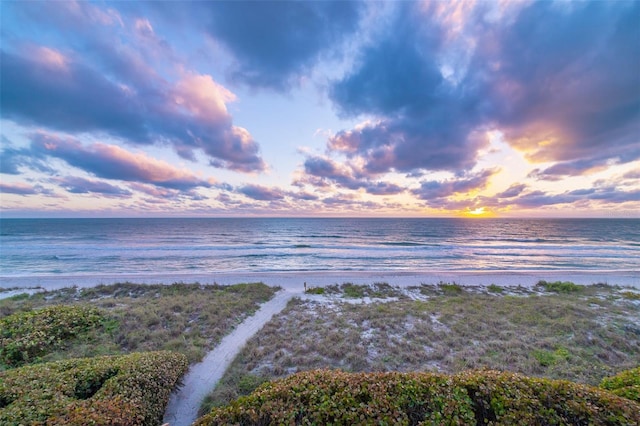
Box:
<box><xmin>0</xmin><ymin>283</ymin><xmax>276</xmax><ymax>364</ymax></box>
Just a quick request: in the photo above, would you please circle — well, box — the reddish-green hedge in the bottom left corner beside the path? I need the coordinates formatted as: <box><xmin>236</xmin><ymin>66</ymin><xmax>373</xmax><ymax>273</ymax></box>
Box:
<box><xmin>0</xmin><ymin>352</ymin><xmax>188</xmax><ymax>426</ymax></box>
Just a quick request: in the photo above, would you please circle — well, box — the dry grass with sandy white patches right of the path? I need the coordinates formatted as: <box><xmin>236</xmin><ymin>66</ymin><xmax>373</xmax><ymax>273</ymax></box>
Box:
<box><xmin>201</xmin><ymin>283</ymin><xmax>640</xmax><ymax>412</ymax></box>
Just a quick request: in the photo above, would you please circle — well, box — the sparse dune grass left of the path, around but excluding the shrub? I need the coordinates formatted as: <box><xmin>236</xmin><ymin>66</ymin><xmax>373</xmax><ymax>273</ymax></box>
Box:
<box><xmin>0</xmin><ymin>283</ymin><xmax>276</xmax><ymax>370</ymax></box>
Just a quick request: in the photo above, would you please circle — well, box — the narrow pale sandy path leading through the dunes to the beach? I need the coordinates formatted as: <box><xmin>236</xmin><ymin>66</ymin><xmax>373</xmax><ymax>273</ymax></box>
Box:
<box><xmin>164</xmin><ymin>290</ymin><xmax>302</xmax><ymax>426</ymax></box>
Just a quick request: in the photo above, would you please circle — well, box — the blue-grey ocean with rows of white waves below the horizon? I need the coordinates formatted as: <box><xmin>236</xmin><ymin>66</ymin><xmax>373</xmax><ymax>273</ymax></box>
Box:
<box><xmin>0</xmin><ymin>218</ymin><xmax>640</xmax><ymax>278</ymax></box>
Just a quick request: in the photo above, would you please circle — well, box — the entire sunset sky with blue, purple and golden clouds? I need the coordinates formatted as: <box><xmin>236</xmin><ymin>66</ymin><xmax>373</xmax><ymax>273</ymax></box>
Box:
<box><xmin>0</xmin><ymin>0</ymin><xmax>640</xmax><ymax>218</ymax></box>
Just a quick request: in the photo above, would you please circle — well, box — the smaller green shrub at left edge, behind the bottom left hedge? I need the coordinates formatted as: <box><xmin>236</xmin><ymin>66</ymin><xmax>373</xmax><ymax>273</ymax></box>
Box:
<box><xmin>0</xmin><ymin>305</ymin><xmax>103</xmax><ymax>367</ymax></box>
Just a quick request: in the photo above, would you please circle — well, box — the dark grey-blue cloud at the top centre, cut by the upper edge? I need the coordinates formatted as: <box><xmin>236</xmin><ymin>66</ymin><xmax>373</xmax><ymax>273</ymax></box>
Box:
<box><xmin>198</xmin><ymin>1</ymin><xmax>363</xmax><ymax>90</ymax></box>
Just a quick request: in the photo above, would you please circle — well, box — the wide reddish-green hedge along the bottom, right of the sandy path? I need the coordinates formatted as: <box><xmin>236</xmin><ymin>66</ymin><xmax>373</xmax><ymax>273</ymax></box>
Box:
<box><xmin>195</xmin><ymin>370</ymin><xmax>640</xmax><ymax>426</ymax></box>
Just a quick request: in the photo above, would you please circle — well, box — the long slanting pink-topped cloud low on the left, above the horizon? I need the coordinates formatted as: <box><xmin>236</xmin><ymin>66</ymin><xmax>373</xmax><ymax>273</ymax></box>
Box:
<box><xmin>31</xmin><ymin>133</ymin><xmax>211</xmax><ymax>190</ymax></box>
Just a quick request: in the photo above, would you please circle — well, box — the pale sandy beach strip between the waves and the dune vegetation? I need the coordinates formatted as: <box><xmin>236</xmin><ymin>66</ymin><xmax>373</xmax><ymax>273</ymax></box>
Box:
<box><xmin>0</xmin><ymin>270</ymin><xmax>640</xmax><ymax>292</ymax></box>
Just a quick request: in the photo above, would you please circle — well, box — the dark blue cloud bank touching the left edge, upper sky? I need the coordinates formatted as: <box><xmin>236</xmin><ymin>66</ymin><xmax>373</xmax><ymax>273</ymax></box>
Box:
<box><xmin>0</xmin><ymin>49</ymin><xmax>149</xmax><ymax>142</ymax></box>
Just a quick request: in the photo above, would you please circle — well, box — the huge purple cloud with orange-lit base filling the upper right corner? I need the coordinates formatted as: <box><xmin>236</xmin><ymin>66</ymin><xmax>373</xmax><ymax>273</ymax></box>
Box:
<box><xmin>474</xmin><ymin>2</ymin><xmax>640</xmax><ymax>167</ymax></box>
